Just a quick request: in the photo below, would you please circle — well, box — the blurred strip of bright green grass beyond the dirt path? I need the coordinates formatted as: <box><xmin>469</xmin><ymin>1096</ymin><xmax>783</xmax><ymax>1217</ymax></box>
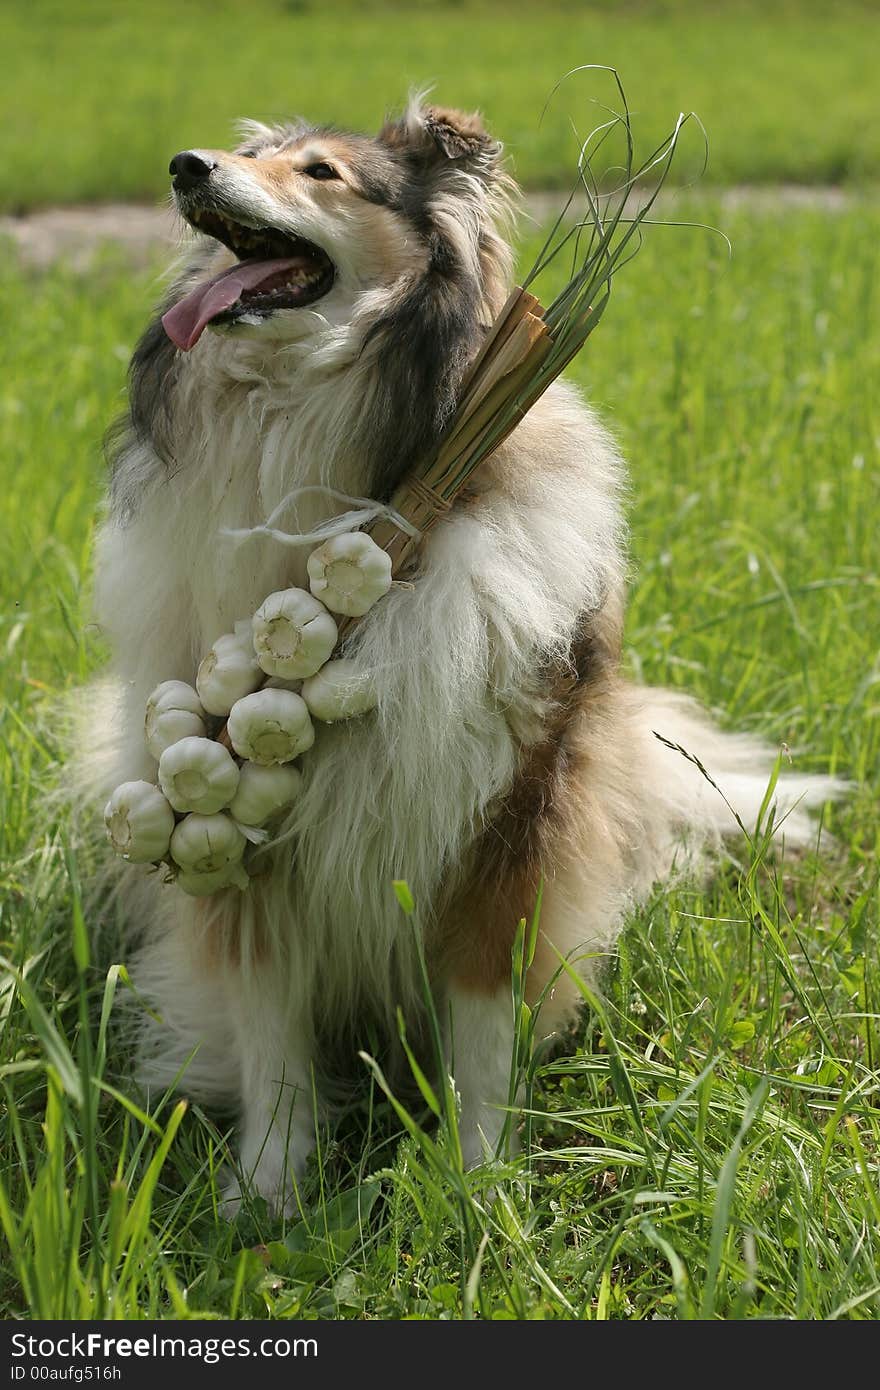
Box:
<box><xmin>0</xmin><ymin>0</ymin><xmax>880</xmax><ymax>210</ymax></box>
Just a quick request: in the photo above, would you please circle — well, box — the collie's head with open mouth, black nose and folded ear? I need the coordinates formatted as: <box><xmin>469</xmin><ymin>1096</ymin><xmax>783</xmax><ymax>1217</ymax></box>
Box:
<box><xmin>163</xmin><ymin>100</ymin><xmax>509</xmax><ymax>352</ymax></box>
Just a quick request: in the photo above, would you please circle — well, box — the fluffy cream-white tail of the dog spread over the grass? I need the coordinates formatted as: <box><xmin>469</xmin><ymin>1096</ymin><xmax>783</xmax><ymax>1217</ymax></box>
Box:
<box><xmin>617</xmin><ymin>687</ymin><xmax>849</xmax><ymax>897</ymax></box>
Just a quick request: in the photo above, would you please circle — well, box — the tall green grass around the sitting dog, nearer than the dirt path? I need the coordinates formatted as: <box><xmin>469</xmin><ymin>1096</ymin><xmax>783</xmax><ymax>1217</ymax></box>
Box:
<box><xmin>0</xmin><ymin>202</ymin><xmax>880</xmax><ymax>1319</ymax></box>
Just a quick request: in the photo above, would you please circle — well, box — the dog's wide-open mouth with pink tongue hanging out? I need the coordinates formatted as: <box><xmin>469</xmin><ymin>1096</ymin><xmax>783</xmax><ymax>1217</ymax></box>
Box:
<box><xmin>163</xmin><ymin>210</ymin><xmax>335</xmax><ymax>352</ymax></box>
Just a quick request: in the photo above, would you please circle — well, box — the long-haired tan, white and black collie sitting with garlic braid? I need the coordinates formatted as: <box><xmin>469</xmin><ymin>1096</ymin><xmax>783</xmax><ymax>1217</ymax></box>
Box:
<box><xmin>88</xmin><ymin>100</ymin><xmax>834</xmax><ymax>1209</ymax></box>
